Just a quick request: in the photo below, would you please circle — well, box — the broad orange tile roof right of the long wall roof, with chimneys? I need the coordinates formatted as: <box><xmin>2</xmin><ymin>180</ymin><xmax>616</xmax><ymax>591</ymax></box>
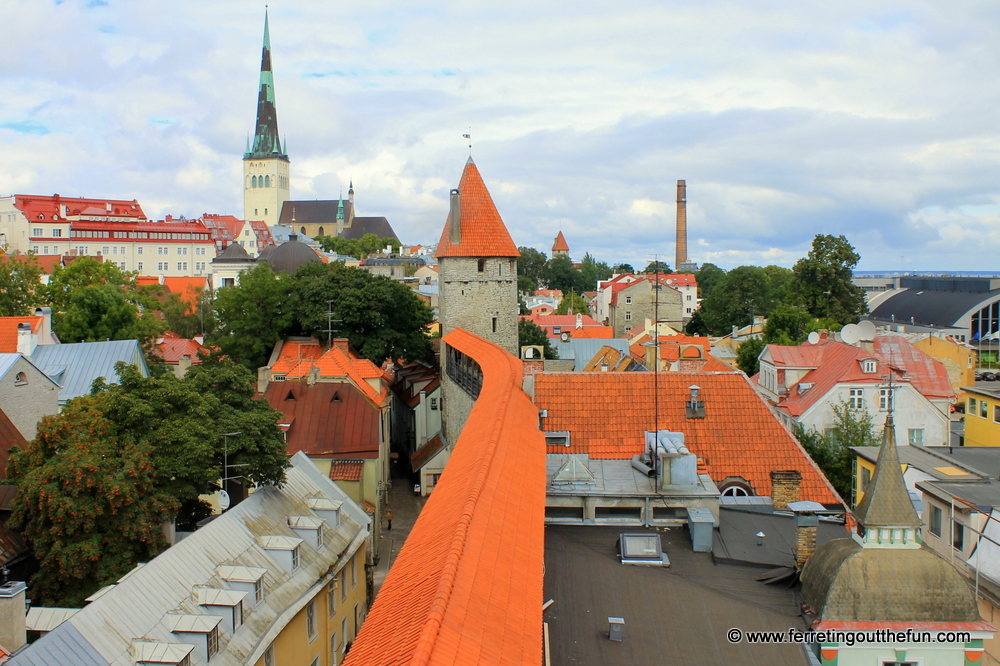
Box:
<box><xmin>535</xmin><ymin>372</ymin><xmax>842</xmax><ymax>504</ymax></box>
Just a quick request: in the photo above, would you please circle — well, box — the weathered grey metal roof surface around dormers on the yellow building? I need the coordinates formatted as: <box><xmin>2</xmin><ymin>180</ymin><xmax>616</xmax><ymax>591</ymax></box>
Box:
<box><xmin>8</xmin><ymin>453</ymin><xmax>369</xmax><ymax>666</ymax></box>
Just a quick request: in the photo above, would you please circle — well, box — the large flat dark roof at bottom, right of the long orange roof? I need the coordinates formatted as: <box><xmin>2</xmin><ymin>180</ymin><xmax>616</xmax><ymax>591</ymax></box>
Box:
<box><xmin>544</xmin><ymin>525</ymin><xmax>809</xmax><ymax>666</ymax></box>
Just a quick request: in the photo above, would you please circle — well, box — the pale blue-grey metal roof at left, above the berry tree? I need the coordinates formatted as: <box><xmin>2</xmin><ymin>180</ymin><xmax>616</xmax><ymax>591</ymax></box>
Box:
<box><xmin>31</xmin><ymin>340</ymin><xmax>149</xmax><ymax>403</ymax></box>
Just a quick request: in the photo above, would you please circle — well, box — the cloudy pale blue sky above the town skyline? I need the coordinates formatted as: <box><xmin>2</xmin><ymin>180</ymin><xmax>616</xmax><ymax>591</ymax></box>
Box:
<box><xmin>0</xmin><ymin>0</ymin><xmax>1000</xmax><ymax>271</ymax></box>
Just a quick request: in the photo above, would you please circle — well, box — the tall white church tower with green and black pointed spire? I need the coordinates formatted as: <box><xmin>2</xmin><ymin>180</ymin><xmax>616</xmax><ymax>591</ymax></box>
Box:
<box><xmin>243</xmin><ymin>11</ymin><xmax>290</xmax><ymax>226</ymax></box>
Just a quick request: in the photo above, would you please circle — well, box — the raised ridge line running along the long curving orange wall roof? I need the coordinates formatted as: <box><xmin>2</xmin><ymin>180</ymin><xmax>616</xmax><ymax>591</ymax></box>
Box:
<box><xmin>410</xmin><ymin>328</ymin><xmax>513</xmax><ymax>666</ymax></box>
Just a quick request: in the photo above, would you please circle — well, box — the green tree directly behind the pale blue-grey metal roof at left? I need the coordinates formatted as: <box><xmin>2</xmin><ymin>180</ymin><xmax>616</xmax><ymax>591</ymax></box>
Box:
<box><xmin>52</xmin><ymin>284</ymin><xmax>165</xmax><ymax>351</ymax></box>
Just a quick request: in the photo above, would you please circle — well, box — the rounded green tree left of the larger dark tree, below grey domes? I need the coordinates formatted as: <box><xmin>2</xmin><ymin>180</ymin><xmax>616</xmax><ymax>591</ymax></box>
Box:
<box><xmin>207</xmin><ymin>262</ymin><xmax>292</xmax><ymax>371</ymax></box>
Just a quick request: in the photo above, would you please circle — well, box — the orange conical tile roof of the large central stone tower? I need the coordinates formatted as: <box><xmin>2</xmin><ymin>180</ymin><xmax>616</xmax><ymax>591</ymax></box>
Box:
<box><xmin>434</xmin><ymin>157</ymin><xmax>521</xmax><ymax>258</ymax></box>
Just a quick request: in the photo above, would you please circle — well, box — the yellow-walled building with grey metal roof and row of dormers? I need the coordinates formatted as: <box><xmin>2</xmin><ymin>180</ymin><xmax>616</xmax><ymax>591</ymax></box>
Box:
<box><xmin>4</xmin><ymin>454</ymin><xmax>371</xmax><ymax>666</ymax></box>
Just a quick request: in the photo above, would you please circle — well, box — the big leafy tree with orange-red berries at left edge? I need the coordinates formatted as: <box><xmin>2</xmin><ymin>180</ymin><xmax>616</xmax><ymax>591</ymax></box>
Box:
<box><xmin>7</xmin><ymin>396</ymin><xmax>177</xmax><ymax>608</ymax></box>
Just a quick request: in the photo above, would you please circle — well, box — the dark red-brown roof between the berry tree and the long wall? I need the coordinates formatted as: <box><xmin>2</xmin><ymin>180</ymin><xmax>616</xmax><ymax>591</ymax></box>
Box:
<box><xmin>264</xmin><ymin>382</ymin><xmax>379</xmax><ymax>458</ymax></box>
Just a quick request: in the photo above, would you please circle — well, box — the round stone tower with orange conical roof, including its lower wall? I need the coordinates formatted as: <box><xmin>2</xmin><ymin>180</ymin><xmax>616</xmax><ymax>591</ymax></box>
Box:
<box><xmin>435</xmin><ymin>157</ymin><xmax>521</xmax><ymax>444</ymax></box>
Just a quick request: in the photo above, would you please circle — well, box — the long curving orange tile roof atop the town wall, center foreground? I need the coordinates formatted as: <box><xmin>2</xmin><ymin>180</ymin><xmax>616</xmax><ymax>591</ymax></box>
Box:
<box><xmin>344</xmin><ymin>329</ymin><xmax>545</xmax><ymax>666</ymax></box>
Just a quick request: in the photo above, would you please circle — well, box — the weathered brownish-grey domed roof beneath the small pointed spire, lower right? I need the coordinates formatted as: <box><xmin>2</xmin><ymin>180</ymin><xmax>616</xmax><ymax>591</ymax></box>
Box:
<box><xmin>802</xmin><ymin>539</ymin><xmax>980</xmax><ymax>622</ymax></box>
